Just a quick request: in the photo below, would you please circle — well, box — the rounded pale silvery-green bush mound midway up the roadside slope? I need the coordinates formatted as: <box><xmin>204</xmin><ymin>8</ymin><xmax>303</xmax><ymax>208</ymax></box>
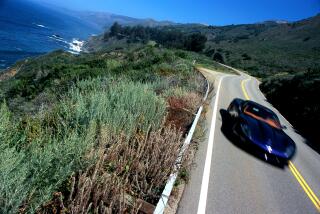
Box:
<box><xmin>61</xmin><ymin>78</ymin><xmax>166</xmax><ymax>139</ymax></box>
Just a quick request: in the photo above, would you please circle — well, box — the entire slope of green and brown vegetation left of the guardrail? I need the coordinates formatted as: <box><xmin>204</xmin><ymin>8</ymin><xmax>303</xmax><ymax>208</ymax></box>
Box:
<box><xmin>0</xmin><ymin>45</ymin><xmax>231</xmax><ymax>213</ymax></box>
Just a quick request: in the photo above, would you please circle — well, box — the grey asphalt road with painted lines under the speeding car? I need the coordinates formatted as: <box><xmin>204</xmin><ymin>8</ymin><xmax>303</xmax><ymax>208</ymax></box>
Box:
<box><xmin>177</xmin><ymin>67</ymin><xmax>320</xmax><ymax>214</ymax></box>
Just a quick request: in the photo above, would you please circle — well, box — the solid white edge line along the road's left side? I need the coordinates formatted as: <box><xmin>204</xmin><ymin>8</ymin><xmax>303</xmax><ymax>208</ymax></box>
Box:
<box><xmin>197</xmin><ymin>76</ymin><xmax>224</xmax><ymax>214</ymax></box>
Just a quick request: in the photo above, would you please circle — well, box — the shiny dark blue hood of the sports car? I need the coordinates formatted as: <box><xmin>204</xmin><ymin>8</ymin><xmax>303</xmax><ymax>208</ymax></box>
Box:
<box><xmin>246</xmin><ymin>117</ymin><xmax>295</xmax><ymax>153</ymax></box>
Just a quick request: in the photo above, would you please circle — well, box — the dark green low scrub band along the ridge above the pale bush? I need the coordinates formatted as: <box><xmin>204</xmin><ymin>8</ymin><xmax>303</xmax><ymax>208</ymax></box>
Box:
<box><xmin>0</xmin><ymin>45</ymin><xmax>214</xmax><ymax>113</ymax></box>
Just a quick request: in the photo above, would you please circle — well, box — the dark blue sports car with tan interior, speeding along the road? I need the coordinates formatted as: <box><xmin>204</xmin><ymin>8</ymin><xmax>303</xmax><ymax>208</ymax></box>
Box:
<box><xmin>228</xmin><ymin>98</ymin><xmax>296</xmax><ymax>163</ymax></box>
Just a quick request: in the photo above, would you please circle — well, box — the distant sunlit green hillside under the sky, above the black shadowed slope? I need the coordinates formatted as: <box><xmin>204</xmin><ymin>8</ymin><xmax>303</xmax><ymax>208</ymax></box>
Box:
<box><xmin>153</xmin><ymin>15</ymin><xmax>320</xmax><ymax>77</ymax></box>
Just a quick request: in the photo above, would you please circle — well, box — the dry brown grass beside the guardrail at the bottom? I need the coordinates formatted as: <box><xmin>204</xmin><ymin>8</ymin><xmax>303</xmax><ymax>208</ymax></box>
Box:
<box><xmin>41</xmin><ymin>124</ymin><xmax>182</xmax><ymax>214</ymax></box>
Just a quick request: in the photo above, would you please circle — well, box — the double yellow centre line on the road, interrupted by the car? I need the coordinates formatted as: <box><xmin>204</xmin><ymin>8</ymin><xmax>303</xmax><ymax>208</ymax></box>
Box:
<box><xmin>241</xmin><ymin>78</ymin><xmax>320</xmax><ymax>213</ymax></box>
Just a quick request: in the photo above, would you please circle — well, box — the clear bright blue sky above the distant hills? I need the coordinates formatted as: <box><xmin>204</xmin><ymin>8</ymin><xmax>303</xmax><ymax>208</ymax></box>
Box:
<box><xmin>33</xmin><ymin>0</ymin><xmax>320</xmax><ymax>25</ymax></box>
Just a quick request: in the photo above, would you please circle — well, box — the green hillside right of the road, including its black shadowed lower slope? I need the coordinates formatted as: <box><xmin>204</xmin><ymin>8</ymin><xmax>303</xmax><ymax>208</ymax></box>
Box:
<box><xmin>201</xmin><ymin>15</ymin><xmax>320</xmax><ymax>149</ymax></box>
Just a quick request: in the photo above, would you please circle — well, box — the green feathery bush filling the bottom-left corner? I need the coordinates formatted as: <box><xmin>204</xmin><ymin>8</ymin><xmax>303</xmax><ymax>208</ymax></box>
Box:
<box><xmin>0</xmin><ymin>101</ymin><xmax>96</xmax><ymax>213</ymax></box>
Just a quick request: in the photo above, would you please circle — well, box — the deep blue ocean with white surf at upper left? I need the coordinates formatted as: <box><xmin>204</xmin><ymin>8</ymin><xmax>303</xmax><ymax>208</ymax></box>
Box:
<box><xmin>0</xmin><ymin>0</ymin><xmax>100</xmax><ymax>70</ymax></box>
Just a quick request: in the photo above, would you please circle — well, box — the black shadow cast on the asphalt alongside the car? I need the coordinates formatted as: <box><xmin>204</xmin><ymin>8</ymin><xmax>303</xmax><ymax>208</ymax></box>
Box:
<box><xmin>220</xmin><ymin>109</ymin><xmax>287</xmax><ymax>169</ymax></box>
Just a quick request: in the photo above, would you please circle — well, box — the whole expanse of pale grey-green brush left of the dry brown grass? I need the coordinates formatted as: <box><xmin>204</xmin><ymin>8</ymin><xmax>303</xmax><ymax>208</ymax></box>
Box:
<box><xmin>0</xmin><ymin>79</ymin><xmax>166</xmax><ymax>213</ymax></box>
